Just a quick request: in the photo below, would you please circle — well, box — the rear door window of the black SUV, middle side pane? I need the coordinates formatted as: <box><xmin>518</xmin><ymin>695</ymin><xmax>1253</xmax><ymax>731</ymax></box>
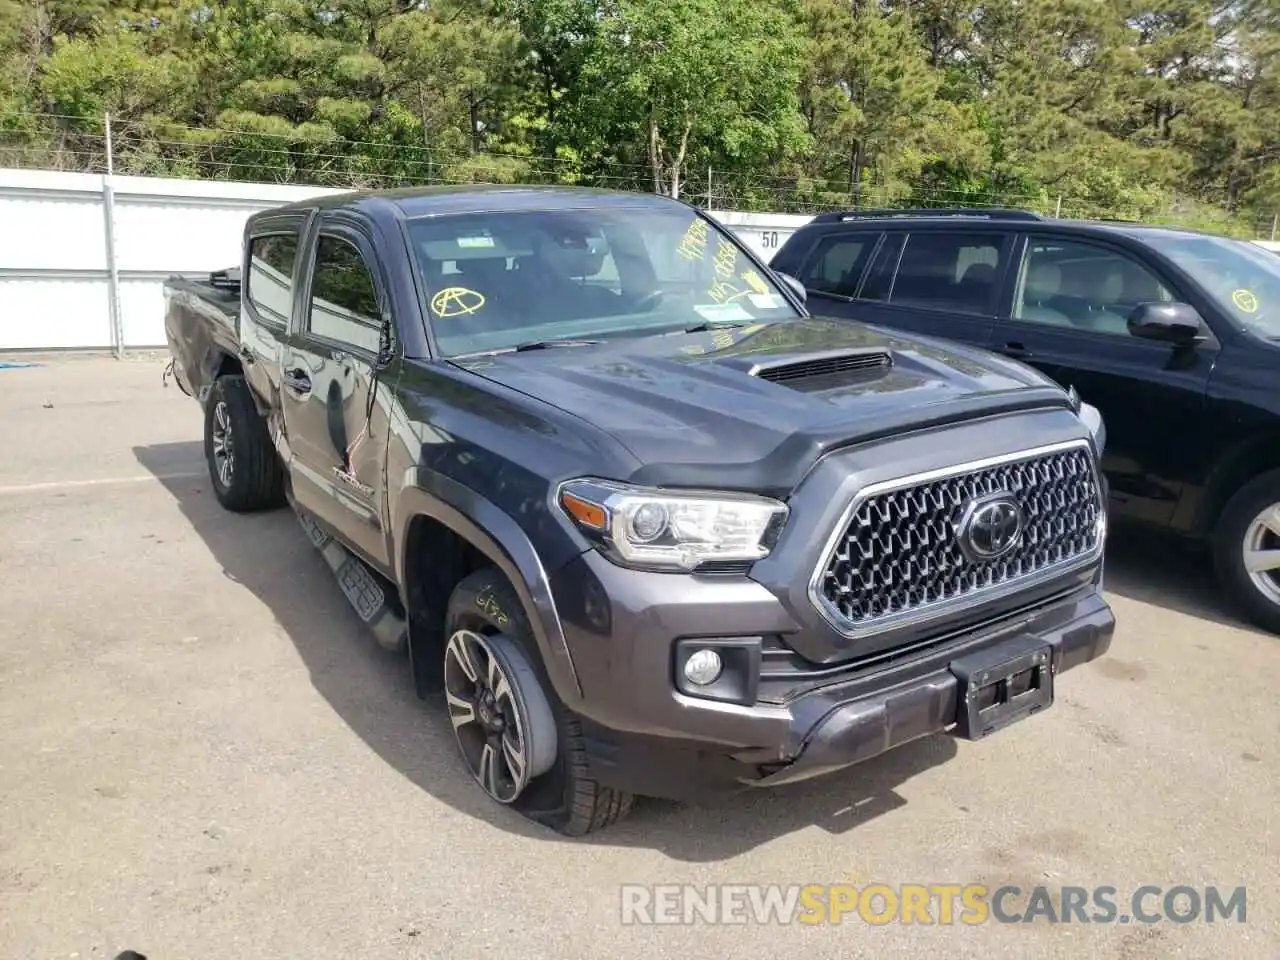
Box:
<box><xmin>890</xmin><ymin>232</ymin><xmax>1005</xmax><ymax>314</ymax></box>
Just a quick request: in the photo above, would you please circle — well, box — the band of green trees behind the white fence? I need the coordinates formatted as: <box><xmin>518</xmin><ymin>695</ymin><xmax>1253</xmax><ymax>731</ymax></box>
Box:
<box><xmin>0</xmin><ymin>0</ymin><xmax>1280</xmax><ymax>229</ymax></box>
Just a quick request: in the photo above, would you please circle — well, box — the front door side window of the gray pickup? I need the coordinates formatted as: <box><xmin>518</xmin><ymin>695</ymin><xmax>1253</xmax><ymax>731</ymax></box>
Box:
<box><xmin>307</xmin><ymin>237</ymin><xmax>381</xmax><ymax>353</ymax></box>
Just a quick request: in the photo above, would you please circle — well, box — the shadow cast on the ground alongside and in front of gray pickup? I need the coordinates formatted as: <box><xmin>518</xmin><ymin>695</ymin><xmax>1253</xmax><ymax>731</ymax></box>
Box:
<box><xmin>133</xmin><ymin>442</ymin><xmax>956</xmax><ymax>861</ymax></box>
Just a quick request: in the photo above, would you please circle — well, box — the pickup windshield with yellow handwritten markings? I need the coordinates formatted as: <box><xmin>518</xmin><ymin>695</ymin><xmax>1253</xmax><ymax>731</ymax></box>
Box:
<box><xmin>408</xmin><ymin>204</ymin><xmax>799</xmax><ymax>357</ymax></box>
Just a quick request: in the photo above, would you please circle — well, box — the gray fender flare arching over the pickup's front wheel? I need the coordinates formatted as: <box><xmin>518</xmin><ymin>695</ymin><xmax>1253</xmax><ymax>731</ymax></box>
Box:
<box><xmin>393</xmin><ymin>470</ymin><xmax>582</xmax><ymax>707</ymax></box>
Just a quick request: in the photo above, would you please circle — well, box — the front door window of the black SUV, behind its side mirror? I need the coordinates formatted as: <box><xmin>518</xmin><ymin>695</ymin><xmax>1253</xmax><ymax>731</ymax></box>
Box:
<box><xmin>1014</xmin><ymin>237</ymin><xmax>1175</xmax><ymax>337</ymax></box>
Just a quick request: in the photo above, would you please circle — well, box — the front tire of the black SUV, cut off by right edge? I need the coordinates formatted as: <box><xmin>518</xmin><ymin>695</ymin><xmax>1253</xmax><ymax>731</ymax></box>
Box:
<box><xmin>1213</xmin><ymin>470</ymin><xmax>1280</xmax><ymax>634</ymax></box>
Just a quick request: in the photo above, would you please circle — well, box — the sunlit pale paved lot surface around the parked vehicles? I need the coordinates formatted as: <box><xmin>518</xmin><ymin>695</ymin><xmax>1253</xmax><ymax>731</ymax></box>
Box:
<box><xmin>0</xmin><ymin>358</ymin><xmax>1280</xmax><ymax>960</ymax></box>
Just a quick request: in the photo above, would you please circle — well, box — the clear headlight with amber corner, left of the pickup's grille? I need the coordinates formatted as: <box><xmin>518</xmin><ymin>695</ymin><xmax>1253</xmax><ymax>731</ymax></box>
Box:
<box><xmin>559</xmin><ymin>480</ymin><xmax>787</xmax><ymax>572</ymax></box>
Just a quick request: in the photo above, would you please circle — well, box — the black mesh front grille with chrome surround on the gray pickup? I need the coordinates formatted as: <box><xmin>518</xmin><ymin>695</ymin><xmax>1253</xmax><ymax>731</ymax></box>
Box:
<box><xmin>814</xmin><ymin>444</ymin><xmax>1103</xmax><ymax>634</ymax></box>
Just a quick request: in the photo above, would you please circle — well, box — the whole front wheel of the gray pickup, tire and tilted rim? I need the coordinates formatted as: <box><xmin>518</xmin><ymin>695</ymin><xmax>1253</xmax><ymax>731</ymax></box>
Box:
<box><xmin>444</xmin><ymin>568</ymin><xmax>632</xmax><ymax>837</ymax></box>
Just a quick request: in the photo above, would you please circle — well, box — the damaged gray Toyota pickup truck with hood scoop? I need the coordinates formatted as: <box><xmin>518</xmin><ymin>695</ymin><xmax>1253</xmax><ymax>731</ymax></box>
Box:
<box><xmin>165</xmin><ymin>187</ymin><xmax>1115</xmax><ymax>835</ymax></box>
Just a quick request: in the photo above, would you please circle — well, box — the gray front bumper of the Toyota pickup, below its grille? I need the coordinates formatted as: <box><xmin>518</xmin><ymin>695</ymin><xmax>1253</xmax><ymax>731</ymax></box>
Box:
<box><xmin>553</xmin><ymin>553</ymin><xmax>1115</xmax><ymax>800</ymax></box>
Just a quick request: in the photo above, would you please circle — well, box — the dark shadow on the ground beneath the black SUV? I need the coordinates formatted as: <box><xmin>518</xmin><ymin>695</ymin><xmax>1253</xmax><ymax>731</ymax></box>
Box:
<box><xmin>1105</xmin><ymin>527</ymin><xmax>1253</xmax><ymax>630</ymax></box>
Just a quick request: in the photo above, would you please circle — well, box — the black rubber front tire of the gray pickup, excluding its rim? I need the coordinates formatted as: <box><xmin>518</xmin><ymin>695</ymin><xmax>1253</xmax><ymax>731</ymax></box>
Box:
<box><xmin>445</xmin><ymin>567</ymin><xmax>634</xmax><ymax>837</ymax></box>
